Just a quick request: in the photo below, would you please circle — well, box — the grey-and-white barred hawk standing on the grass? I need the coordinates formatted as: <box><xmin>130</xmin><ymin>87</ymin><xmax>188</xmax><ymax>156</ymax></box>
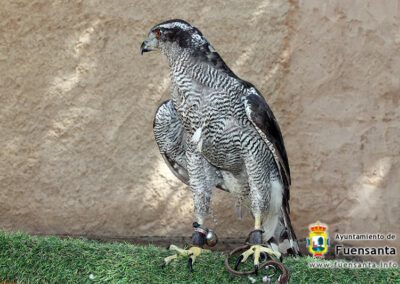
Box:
<box><xmin>140</xmin><ymin>20</ymin><xmax>299</xmax><ymax>268</ymax></box>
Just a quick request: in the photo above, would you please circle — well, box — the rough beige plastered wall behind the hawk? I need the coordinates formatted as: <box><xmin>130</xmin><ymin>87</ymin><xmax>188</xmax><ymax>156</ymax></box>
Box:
<box><xmin>0</xmin><ymin>0</ymin><xmax>400</xmax><ymax>252</ymax></box>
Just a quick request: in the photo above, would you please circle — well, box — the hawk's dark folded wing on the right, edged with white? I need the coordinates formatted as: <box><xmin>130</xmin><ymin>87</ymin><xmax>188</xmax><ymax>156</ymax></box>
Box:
<box><xmin>242</xmin><ymin>90</ymin><xmax>291</xmax><ymax>211</ymax></box>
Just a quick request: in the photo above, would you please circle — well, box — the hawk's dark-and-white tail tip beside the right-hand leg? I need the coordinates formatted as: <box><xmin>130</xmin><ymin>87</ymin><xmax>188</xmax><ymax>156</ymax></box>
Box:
<box><xmin>271</xmin><ymin>206</ymin><xmax>301</xmax><ymax>256</ymax></box>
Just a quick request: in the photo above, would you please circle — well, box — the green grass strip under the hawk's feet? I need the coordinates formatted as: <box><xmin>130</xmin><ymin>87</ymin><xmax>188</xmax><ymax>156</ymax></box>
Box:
<box><xmin>0</xmin><ymin>231</ymin><xmax>400</xmax><ymax>283</ymax></box>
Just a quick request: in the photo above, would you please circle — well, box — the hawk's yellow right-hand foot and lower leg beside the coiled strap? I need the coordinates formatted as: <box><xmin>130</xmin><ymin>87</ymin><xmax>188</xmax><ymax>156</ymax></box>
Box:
<box><xmin>235</xmin><ymin>214</ymin><xmax>281</xmax><ymax>271</ymax></box>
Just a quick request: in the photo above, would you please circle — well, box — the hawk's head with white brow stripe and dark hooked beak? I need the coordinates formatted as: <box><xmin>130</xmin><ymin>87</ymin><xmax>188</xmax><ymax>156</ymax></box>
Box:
<box><xmin>140</xmin><ymin>20</ymin><xmax>208</xmax><ymax>55</ymax></box>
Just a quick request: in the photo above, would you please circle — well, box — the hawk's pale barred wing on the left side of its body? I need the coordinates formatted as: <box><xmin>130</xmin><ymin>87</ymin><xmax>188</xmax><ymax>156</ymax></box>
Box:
<box><xmin>153</xmin><ymin>100</ymin><xmax>189</xmax><ymax>185</ymax></box>
